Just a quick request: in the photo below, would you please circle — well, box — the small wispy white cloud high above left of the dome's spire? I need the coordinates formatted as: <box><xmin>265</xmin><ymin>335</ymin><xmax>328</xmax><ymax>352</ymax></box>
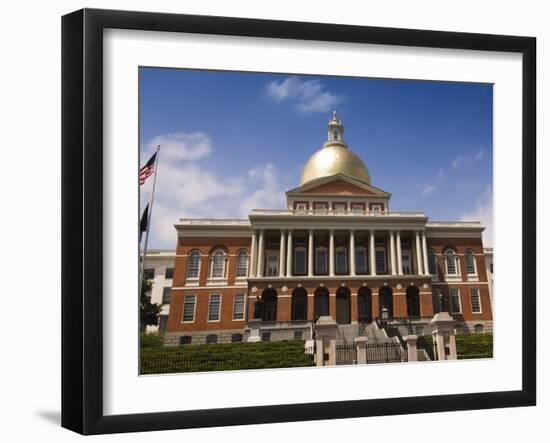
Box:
<box><xmin>267</xmin><ymin>76</ymin><xmax>343</xmax><ymax>113</ymax></box>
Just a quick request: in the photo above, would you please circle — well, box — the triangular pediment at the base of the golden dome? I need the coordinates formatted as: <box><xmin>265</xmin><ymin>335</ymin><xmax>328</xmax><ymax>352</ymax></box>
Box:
<box><xmin>287</xmin><ymin>174</ymin><xmax>390</xmax><ymax>197</ymax></box>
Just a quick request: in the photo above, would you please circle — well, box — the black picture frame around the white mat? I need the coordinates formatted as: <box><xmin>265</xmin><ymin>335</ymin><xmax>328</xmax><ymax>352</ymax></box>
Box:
<box><xmin>62</xmin><ymin>9</ymin><xmax>536</xmax><ymax>434</ymax></box>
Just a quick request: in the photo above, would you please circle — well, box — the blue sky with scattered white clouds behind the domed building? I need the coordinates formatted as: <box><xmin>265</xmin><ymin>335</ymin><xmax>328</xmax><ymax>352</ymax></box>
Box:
<box><xmin>139</xmin><ymin>68</ymin><xmax>493</xmax><ymax>248</ymax></box>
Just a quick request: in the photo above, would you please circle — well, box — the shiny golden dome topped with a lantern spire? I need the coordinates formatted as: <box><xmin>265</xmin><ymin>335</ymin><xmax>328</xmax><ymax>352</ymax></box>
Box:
<box><xmin>300</xmin><ymin>113</ymin><xmax>370</xmax><ymax>186</ymax></box>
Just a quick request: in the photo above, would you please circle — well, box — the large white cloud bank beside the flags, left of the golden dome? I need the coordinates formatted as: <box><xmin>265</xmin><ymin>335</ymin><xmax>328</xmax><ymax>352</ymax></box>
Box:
<box><xmin>140</xmin><ymin>133</ymin><xmax>284</xmax><ymax>248</ymax></box>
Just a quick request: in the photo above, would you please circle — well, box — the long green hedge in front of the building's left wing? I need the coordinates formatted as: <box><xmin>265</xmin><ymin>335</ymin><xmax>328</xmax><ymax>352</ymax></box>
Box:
<box><xmin>141</xmin><ymin>340</ymin><xmax>315</xmax><ymax>374</ymax></box>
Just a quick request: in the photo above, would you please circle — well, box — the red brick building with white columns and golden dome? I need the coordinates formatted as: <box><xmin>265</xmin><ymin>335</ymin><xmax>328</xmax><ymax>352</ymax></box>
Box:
<box><xmin>166</xmin><ymin>114</ymin><xmax>493</xmax><ymax>345</ymax></box>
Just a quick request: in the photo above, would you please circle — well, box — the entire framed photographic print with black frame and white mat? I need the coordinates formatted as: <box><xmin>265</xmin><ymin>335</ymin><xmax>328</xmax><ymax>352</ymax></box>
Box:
<box><xmin>62</xmin><ymin>9</ymin><xmax>536</xmax><ymax>434</ymax></box>
